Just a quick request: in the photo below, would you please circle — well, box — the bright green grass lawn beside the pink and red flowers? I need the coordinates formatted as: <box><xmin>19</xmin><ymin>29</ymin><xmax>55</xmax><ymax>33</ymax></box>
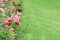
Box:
<box><xmin>18</xmin><ymin>0</ymin><xmax>60</xmax><ymax>40</ymax></box>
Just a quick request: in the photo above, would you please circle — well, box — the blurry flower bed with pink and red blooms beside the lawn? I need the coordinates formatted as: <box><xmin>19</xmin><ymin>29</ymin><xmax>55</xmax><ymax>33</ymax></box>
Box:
<box><xmin>0</xmin><ymin>0</ymin><xmax>22</xmax><ymax>40</ymax></box>
